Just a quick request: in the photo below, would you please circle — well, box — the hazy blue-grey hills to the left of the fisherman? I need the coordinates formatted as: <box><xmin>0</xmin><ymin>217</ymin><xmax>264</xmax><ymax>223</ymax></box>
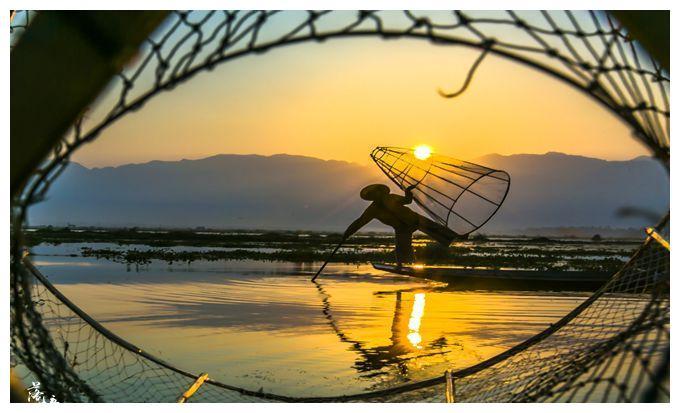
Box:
<box><xmin>30</xmin><ymin>155</ymin><xmax>381</xmax><ymax>229</ymax></box>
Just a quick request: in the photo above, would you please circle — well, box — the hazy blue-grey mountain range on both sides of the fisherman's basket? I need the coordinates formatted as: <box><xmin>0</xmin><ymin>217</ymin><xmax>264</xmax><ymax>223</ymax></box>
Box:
<box><xmin>29</xmin><ymin>153</ymin><xmax>669</xmax><ymax>233</ymax></box>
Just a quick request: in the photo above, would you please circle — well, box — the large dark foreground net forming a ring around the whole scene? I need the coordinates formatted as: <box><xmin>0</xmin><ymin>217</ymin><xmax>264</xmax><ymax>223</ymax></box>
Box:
<box><xmin>10</xmin><ymin>11</ymin><xmax>670</xmax><ymax>402</ymax></box>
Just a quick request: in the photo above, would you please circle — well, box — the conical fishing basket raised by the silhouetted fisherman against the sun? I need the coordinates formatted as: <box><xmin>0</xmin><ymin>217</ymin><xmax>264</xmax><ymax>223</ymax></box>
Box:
<box><xmin>371</xmin><ymin>147</ymin><xmax>510</xmax><ymax>235</ymax></box>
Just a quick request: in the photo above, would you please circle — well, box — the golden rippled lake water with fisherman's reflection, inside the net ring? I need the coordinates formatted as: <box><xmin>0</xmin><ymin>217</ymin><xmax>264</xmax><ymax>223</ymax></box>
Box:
<box><xmin>32</xmin><ymin>244</ymin><xmax>587</xmax><ymax>396</ymax></box>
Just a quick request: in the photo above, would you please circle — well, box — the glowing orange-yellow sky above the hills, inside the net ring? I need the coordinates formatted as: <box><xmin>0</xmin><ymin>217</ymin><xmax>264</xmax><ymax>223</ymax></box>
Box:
<box><xmin>74</xmin><ymin>39</ymin><xmax>647</xmax><ymax>166</ymax></box>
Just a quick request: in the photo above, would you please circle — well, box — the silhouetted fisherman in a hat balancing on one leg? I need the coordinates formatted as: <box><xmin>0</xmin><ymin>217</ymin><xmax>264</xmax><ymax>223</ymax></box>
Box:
<box><xmin>343</xmin><ymin>184</ymin><xmax>465</xmax><ymax>266</ymax></box>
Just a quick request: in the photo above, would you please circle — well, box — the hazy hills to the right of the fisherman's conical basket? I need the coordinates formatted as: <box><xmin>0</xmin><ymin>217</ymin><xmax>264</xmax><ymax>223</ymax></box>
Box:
<box><xmin>476</xmin><ymin>152</ymin><xmax>670</xmax><ymax>232</ymax></box>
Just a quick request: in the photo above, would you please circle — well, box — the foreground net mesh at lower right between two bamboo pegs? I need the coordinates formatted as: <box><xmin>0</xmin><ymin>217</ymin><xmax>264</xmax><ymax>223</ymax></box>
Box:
<box><xmin>456</xmin><ymin>220</ymin><xmax>670</xmax><ymax>402</ymax></box>
